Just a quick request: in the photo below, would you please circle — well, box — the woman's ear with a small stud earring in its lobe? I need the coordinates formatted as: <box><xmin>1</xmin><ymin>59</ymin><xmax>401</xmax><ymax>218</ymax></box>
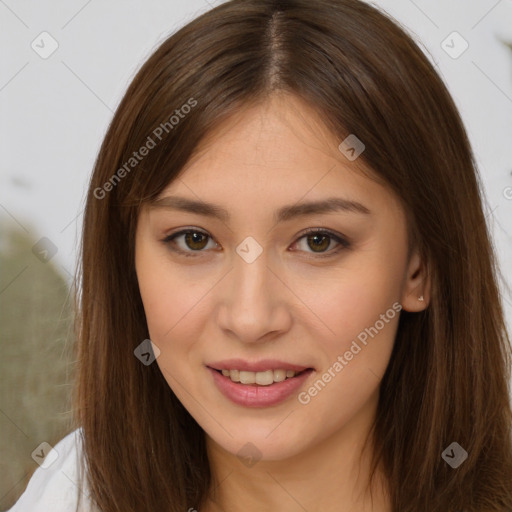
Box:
<box><xmin>401</xmin><ymin>250</ymin><xmax>431</xmax><ymax>313</ymax></box>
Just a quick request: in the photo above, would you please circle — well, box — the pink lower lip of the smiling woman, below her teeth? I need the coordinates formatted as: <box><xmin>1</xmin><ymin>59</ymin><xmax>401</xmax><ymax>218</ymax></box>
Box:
<box><xmin>207</xmin><ymin>367</ymin><xmax>314</xmax><ymax>407</ymax></box>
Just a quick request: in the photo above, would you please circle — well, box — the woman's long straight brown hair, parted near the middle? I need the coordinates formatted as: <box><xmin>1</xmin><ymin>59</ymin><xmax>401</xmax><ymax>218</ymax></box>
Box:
<box><xmin>72</xmin><ymin>0</ymin><xmax>512</xmax><ymax>512</ymax></box>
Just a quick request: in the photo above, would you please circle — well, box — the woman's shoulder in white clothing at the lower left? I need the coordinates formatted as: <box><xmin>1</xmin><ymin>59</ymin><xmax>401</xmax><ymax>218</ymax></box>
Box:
<box><xmin>7</xmin><ymin>428</ymin><xmax>94</xmax><ymax>512</ymax></box>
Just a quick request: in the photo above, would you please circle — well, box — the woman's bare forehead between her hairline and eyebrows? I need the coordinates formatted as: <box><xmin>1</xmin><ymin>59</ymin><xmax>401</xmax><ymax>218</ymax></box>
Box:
<box><xmin>152</xmin><ymin>96</ymin><xmax>404</xmax><ymax>222</ymax></box>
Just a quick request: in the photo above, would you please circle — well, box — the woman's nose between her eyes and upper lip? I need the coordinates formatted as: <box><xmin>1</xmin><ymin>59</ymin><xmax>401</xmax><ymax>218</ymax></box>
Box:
<box><xmin>216</xmin><ymin>251</ymin><xmax>293</xmax><ymax>343</ymax></box>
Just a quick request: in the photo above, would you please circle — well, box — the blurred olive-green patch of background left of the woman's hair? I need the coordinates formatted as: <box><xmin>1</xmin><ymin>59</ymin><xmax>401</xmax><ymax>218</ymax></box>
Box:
<box><xmin>0</xmin><ymin>218</ymin><xmax>75</xmax><ymax>512</ymax></box>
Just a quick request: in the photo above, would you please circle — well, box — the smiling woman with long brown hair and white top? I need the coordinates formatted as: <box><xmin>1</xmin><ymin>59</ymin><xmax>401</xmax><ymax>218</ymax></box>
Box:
<box><xmin>9</xmin><ymin>0</ymin><xmax>512</xmax><ymax>512</ymax></box>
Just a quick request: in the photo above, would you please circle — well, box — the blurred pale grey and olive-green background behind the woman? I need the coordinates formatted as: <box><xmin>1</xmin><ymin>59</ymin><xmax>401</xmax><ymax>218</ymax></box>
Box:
<box><xmin>0</xmin><ymin>0</ymin><xmax>512</xmax><ymax>510</ymax></box>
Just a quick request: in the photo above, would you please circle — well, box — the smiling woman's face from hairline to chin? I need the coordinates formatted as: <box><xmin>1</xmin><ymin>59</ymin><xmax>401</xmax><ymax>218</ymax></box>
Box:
<box><xmin>136</xmin><ymin>93</ymin><xmax>426</xmax><ymax>460</ymax></box>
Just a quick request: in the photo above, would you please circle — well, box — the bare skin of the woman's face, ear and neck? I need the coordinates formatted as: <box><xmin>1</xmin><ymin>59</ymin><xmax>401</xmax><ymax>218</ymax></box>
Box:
<box><xmin>136</xmin><ymin>96</ymin><xmax>429</xmax><ymax>512</ymax></box>
